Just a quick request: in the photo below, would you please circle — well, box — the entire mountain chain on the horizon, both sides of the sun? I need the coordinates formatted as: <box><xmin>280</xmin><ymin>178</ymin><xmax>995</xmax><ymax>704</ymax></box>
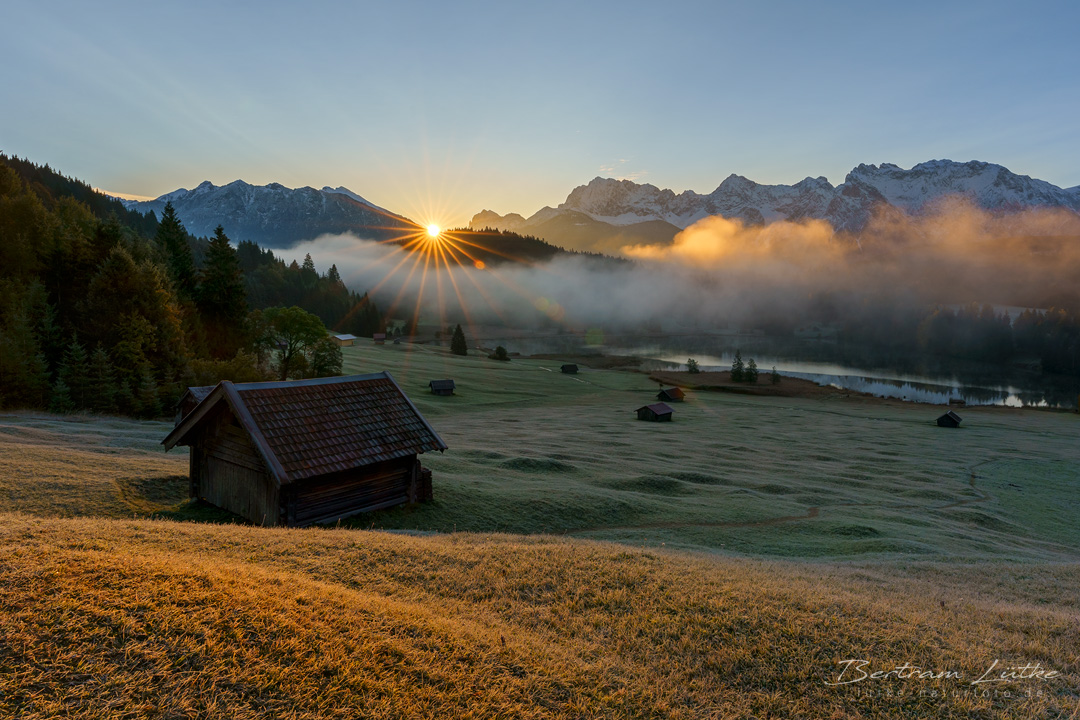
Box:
<box><xmin>125</xmin><ymin>160</ymin><xmax>1080</xmax><ymax>254</ymax></box>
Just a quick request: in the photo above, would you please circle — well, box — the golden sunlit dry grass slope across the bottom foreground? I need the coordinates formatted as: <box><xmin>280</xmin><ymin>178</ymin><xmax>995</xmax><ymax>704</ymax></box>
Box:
<box><xmin>0</xmin><ymin>515</ymin><xmax>1080</xmax><ymax>718</ymax></box>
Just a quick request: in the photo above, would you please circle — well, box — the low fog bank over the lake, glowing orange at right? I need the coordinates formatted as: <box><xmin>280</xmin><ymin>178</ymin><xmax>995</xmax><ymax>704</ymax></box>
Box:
<box><xmin>295</xmin><ymin>199</ymin><xmax>1080</xmax><ymax>329</ymax></box>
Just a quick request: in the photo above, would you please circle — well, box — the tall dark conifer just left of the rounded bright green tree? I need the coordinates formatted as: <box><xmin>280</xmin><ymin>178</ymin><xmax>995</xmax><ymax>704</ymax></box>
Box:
<box><xmin>199</xmin><ymin>226</ymin><xmax>247</xmax><ymax>359</ymax></box>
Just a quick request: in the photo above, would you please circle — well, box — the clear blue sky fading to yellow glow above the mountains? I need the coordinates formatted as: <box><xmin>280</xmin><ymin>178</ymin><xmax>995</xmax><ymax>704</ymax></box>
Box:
<box><xmin>0</xmin><ymin>0</ymin><xmax>1080</xmax><ymax>227</ymax></box>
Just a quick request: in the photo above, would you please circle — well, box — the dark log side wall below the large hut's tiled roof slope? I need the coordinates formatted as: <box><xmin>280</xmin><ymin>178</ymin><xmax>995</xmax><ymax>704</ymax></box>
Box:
<box><xmin>285</xmin><ymin>456</ymin><xmax>421</xmax><ymax>526</ymax></box>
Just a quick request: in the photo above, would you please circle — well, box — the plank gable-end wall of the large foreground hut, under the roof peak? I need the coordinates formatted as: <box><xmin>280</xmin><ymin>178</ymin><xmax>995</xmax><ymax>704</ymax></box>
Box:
<box><xmin>191</xmin><ymin>410</ymin><xmax>281</xmax><ymax>525</ymax></box>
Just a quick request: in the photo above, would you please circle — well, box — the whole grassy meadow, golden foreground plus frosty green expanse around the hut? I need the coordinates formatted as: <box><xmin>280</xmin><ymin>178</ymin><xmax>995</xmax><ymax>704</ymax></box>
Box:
<box><xmin>0</xmin><ymin>345</ymin><xmax>1080</xmax><ymax>718</ymax></box>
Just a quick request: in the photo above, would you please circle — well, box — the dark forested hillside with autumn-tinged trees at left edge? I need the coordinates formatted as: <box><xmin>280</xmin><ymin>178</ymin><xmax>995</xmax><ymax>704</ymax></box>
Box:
<box><xmin>0</xmin><ymin>155</ymin><xmax>383</xmax><ymax>417</ymax></box>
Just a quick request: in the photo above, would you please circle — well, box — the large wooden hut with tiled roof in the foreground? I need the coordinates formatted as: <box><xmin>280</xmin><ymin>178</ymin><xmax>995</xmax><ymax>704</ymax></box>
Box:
<box><xmin>162</xmin><ymin>372</ymin><xmax>446</xmax><ymax>527</ymax></box>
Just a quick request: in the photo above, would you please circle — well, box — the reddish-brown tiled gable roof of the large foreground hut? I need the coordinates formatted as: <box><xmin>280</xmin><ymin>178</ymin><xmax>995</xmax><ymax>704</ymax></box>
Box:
<box><xmin>162</xmin><ymin>372</ymin><xmax>446</xmax><ymax>485</ymax></box>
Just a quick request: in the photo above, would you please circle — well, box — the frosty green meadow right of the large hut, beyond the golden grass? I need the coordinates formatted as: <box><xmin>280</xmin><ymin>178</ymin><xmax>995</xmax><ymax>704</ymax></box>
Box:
<box><xmin>346</xmin><ymin>338</ymin><xmax>1080</xmax><ymax>560</ymax></box>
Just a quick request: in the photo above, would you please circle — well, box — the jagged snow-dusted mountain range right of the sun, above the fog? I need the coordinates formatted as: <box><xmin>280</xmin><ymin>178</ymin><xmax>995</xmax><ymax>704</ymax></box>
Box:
<box><xmin>470</xmin><ymin>160</ymin><xmax>1080</xmax><ymax>253</ymax></box>
